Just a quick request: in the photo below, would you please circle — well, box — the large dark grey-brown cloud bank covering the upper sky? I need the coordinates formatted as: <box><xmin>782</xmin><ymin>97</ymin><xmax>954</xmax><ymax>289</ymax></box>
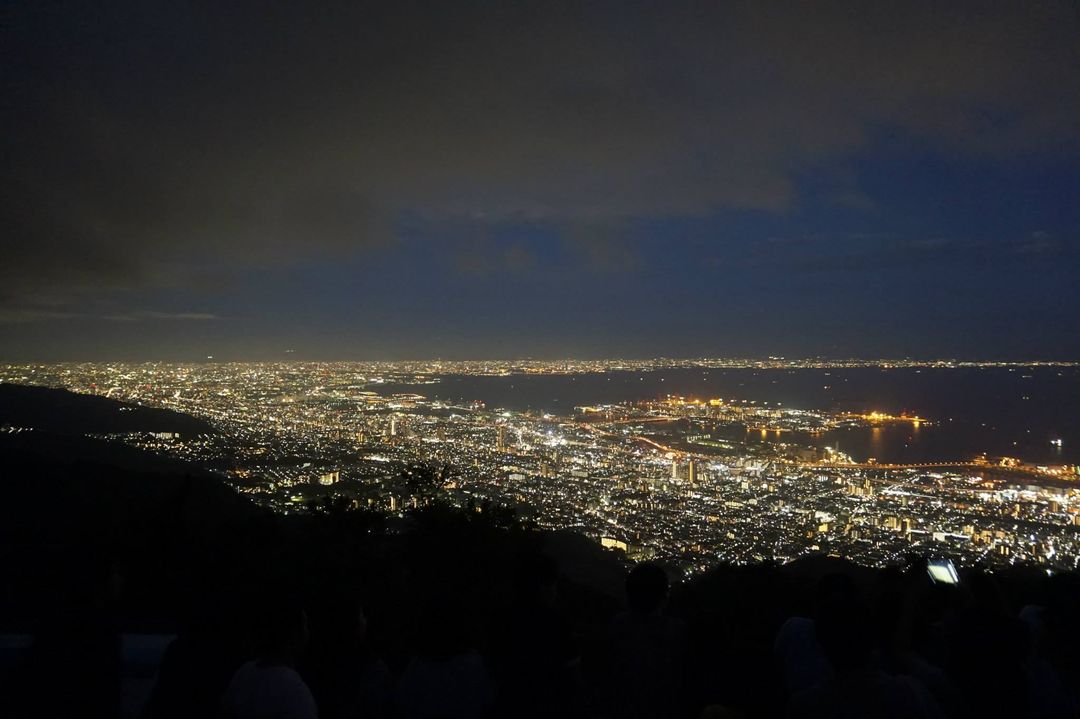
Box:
<box><xmin>0</xmin><ymin>0</ymin><xmax>1080</xmax><ymax>316</ymax></box>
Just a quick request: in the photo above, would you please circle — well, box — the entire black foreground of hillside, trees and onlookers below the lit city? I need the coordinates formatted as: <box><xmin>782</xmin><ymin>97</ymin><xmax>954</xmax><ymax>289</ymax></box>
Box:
<box><xmin>0</xmin><ymin>395</ymin><xmax>1080</xmax><ymax>719</ymax></box>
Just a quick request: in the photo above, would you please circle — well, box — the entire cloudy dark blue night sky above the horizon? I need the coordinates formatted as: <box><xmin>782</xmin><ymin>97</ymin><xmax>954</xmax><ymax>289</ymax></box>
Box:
<box><xmin>0</xmin><ymin>0</ymin><xmax>1080</xmax><ymax>361</ymax></box>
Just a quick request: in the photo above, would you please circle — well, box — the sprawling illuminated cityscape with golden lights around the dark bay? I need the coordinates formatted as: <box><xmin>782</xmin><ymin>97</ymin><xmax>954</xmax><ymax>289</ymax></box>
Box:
<box><xmin>0</xmin><ymin>358</ymin><xmax>1080</xmax><ymax>574</ymax></box>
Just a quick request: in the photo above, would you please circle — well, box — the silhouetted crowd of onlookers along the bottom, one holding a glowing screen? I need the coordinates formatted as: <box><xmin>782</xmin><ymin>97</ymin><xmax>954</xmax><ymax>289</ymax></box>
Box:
<box><xmin>2</xmin><ymin>553</ymin><xmax>1080</xmax><ymax>719</ymax></box>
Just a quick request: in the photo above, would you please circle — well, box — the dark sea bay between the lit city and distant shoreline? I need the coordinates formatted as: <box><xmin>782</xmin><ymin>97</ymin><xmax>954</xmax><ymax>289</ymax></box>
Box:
<box><xmin>382</xmin><ymin>366</ymin><xmax>1080</xmax><ymax>465</ymax></box>
